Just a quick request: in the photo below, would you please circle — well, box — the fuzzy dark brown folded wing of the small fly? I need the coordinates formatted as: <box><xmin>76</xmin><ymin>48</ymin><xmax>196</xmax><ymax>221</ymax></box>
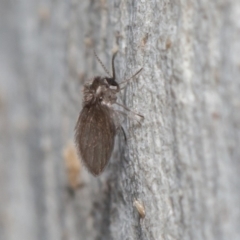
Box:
<box><xmin>75</xmin><ymin>105</ymin><xmax>116</xmax><ymax>175</ymax></box>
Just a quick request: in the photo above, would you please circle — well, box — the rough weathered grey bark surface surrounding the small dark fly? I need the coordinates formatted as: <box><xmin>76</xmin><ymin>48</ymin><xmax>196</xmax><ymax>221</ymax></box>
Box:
<box><xmin>0</xmin><ymin>0</ymin><xmax>240</xmax><ymax>240</ymax></box>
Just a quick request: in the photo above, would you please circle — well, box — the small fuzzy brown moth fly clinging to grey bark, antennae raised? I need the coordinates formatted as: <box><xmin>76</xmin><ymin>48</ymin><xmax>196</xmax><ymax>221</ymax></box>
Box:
<box><xmin>75</xmin><ymin>52</ymin><xmax>143</xmax><ymax>176</ymax></box>
